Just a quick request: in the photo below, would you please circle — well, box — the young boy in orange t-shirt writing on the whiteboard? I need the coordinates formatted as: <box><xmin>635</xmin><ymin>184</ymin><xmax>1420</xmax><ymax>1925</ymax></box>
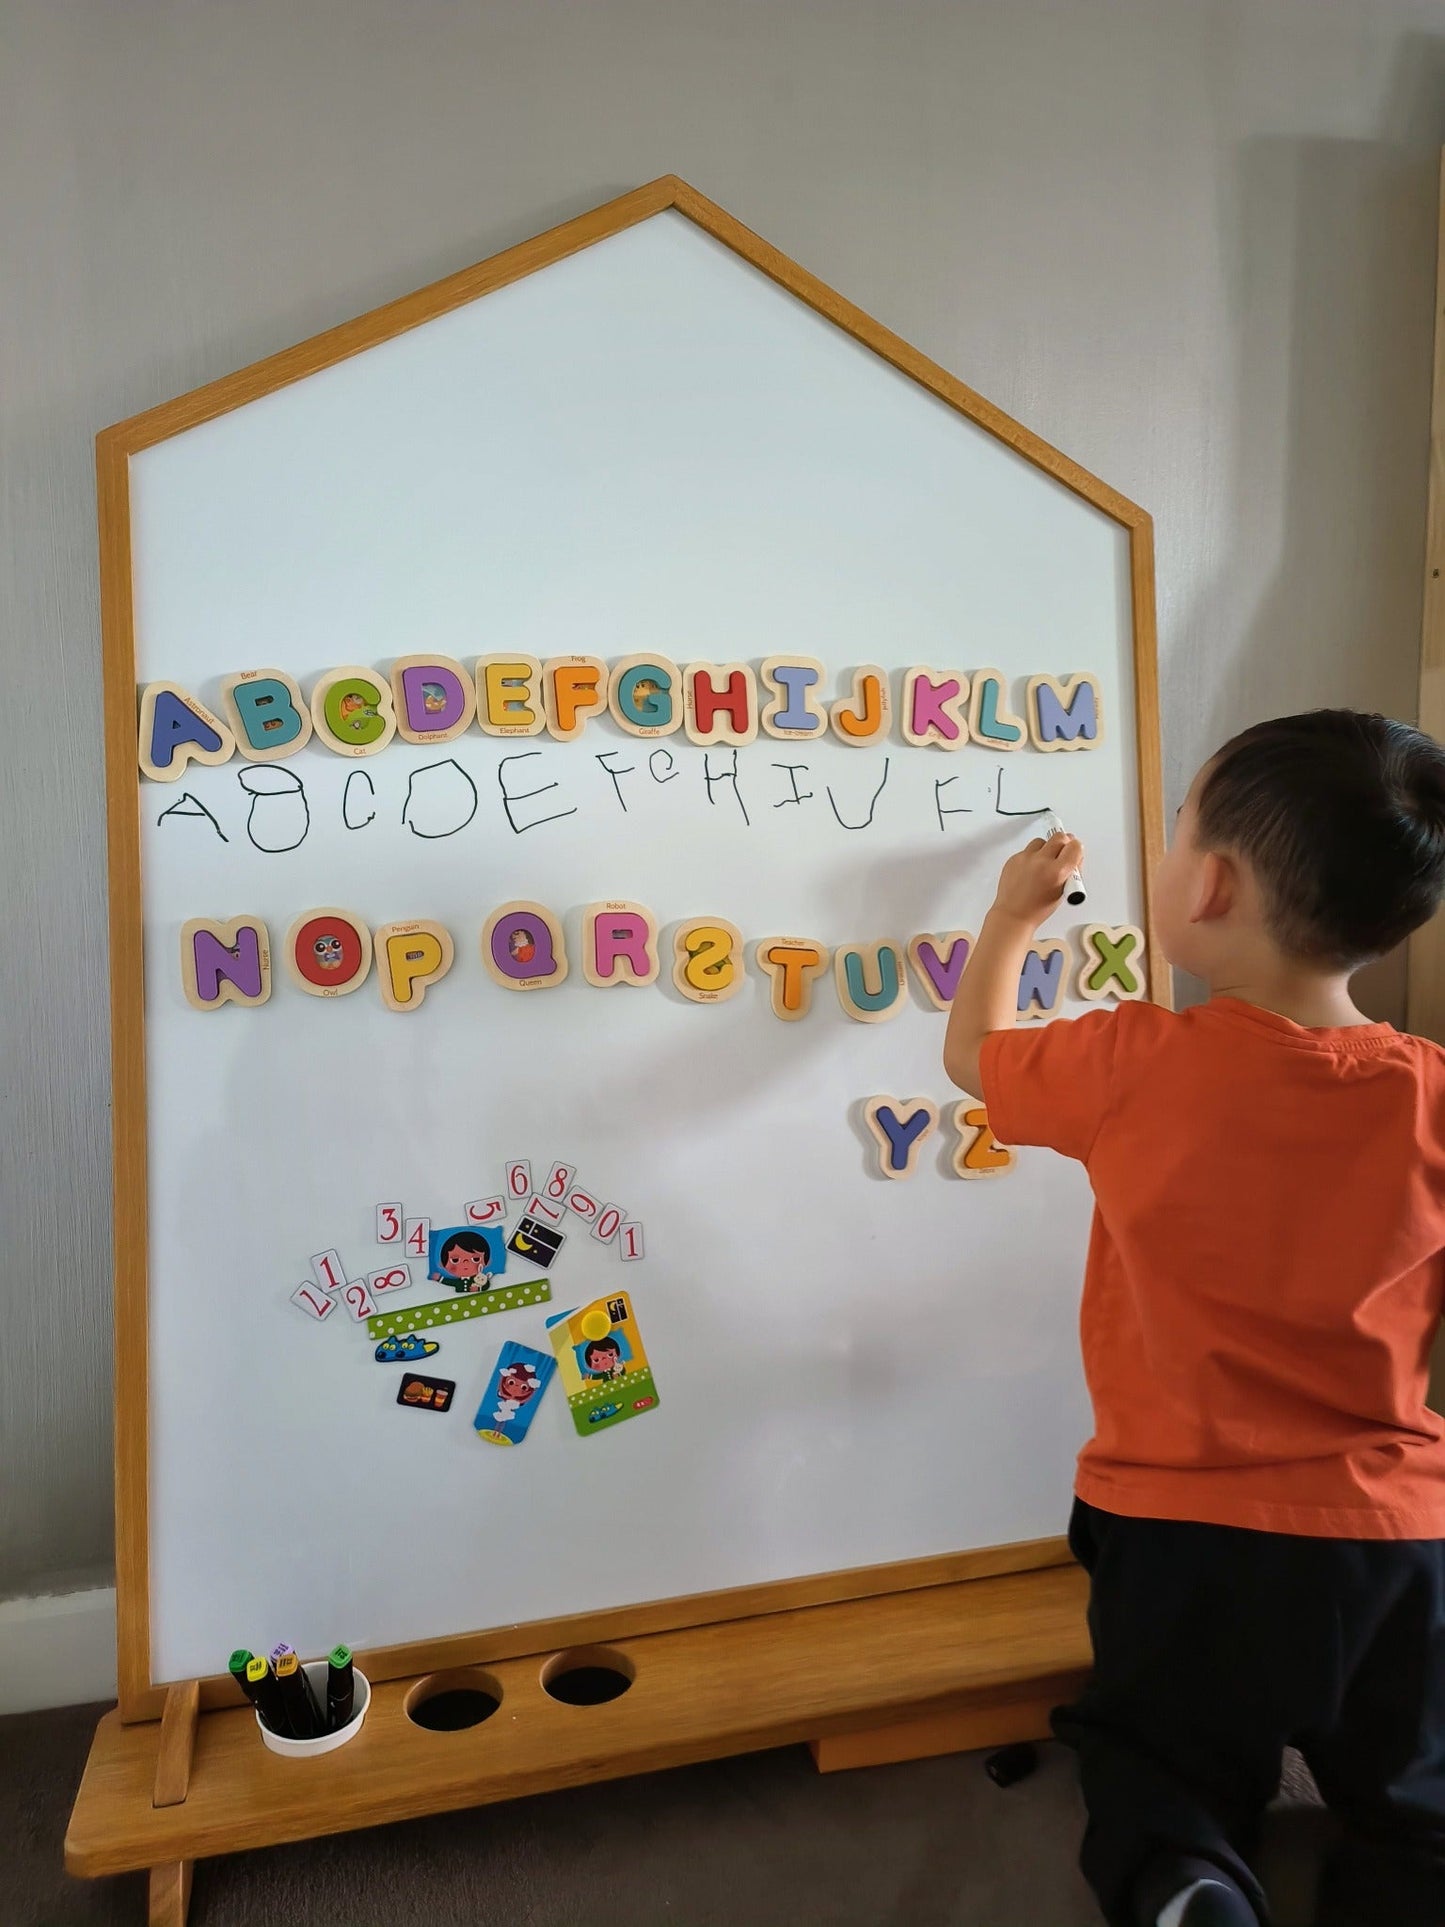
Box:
<box><xmin>944</xmin><ymin>711</ymin><xmax>1445</xmax><ymax>1927</ymax></box>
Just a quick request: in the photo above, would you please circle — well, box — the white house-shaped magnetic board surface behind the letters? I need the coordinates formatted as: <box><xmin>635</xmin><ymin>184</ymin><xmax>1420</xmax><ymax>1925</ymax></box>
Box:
<box><xmin>121</xmin><ymin>212</ymin><xmax>1143</xmax><ymax>1680</ymax></box>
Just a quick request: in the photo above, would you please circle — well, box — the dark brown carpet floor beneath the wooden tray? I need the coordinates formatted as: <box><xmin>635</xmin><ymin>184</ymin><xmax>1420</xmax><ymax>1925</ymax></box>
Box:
<box><xmin>0</xmin><ymin>1707</ymin><xmax>1322</xmax><ymax>1927</ymax></box>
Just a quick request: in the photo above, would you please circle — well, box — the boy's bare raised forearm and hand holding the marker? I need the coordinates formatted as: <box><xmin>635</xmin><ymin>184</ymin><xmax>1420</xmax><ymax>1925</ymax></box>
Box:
<box><xmin>944</xmin><ymin>831</ymin><xmax>1083</xmax><ymax>1096</ymax></box>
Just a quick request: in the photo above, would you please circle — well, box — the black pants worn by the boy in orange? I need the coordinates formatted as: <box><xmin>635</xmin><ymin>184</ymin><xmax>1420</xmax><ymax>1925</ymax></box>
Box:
<box><xmin>1054</xmin><ymin>1501</ymin><xmax>1445</xmax><ymax>1927</ymax></box>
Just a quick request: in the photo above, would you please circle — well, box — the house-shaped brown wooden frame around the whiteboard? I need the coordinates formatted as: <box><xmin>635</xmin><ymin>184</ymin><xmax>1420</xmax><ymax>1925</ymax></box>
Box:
<box><xmin>96</xmin><ymin>175</ymin><xmax>1163</xmax><ymax>1721</ymax></box>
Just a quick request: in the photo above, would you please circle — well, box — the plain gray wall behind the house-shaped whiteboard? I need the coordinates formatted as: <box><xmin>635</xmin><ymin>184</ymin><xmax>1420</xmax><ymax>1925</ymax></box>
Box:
<box><xmin>0</xmin><ymin>0</ymin><xmax>1445</xmax><ymax>1596</ymax></box>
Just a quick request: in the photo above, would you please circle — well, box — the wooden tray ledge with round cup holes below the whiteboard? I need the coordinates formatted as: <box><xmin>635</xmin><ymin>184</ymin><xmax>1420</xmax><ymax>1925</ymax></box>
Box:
<box><xmin>66</xmin><ymin>1565</ymin><xmax>1089</xmax><ymax>1923</ymax></box>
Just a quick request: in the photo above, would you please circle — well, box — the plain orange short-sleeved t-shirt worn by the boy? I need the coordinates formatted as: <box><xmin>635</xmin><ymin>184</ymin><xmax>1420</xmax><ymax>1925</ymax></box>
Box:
<box><xmin>983</xmin><ymin>996</ymin><xmax>1445</xmax><ymax>1540</ymax></box>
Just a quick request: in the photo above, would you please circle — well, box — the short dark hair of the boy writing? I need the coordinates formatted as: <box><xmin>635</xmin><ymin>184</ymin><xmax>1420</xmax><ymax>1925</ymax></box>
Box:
<box><xmin>1198</xmin><ymin>709</ymin><xmax>1445</xmax><ymax>969</ymax></box>
